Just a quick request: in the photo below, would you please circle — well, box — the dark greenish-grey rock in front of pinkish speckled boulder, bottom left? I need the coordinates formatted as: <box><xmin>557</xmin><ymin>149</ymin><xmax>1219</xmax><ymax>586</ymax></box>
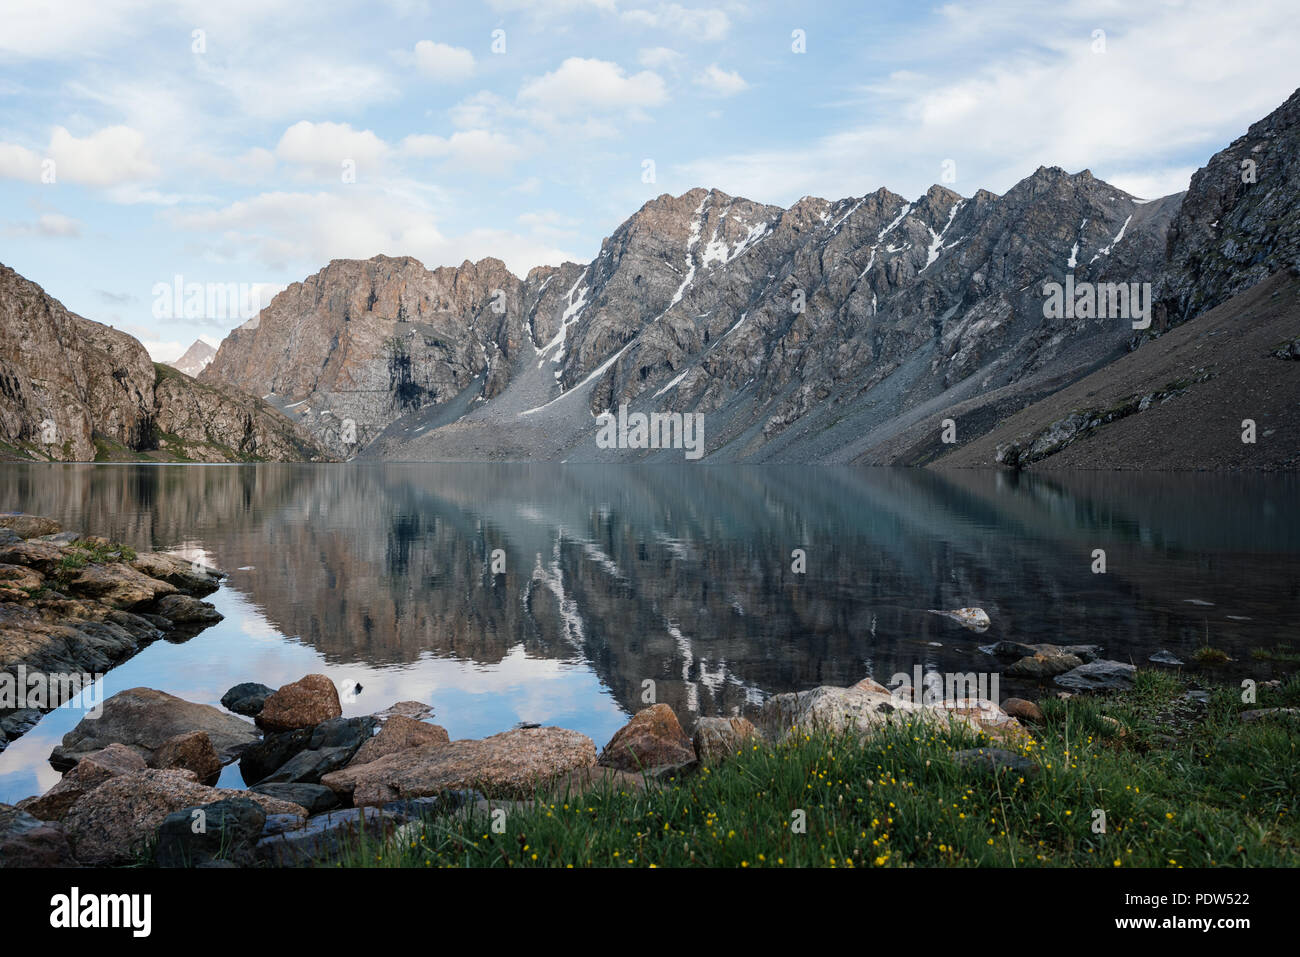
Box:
<box><xmin>153</xmin><ymin>797</ymin><xmax>267</xmax><ymax>867</ymax></box>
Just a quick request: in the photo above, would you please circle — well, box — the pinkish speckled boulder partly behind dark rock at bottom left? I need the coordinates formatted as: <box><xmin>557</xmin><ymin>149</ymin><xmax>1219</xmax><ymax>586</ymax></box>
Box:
<box><xmin>64</xmin><ymin>768</ymin><xmax>307</xmax><ymax>866</ymax></box>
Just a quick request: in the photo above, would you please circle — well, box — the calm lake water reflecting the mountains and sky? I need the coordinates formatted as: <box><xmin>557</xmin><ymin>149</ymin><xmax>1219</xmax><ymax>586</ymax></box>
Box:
<box><xmin>0</xmin><ymin>464</ymin><xmax>1300</xmax><ymax>802</ymax></box>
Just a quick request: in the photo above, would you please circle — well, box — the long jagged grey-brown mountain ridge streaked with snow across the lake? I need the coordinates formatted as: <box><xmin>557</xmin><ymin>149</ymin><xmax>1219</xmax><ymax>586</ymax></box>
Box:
<box><xmin>200</xmin><ymin>87</ymin><xmax>1300</xmax><ymax>464</ymax></box>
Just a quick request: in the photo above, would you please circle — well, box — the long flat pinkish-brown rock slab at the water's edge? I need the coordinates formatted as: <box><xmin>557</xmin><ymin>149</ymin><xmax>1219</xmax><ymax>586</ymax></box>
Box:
<box><xmin>321</xmin><ymin>728</ymin><xmax>595</xmax><ymax>807</ymax></box>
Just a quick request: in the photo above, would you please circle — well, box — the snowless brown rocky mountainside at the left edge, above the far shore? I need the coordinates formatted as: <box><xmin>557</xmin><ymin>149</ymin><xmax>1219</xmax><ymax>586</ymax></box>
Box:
<box><xmin>0</xmin><ymin>265</ymin><xmax>324</xmax><ymax>462</ymax></box>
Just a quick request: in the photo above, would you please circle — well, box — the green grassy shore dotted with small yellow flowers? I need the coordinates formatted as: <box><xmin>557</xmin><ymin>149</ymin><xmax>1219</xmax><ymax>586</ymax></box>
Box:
<box><xmin>343</xmin><ymin>671</ymin><xmax>1300</xmax><ymax>867</ymax></box>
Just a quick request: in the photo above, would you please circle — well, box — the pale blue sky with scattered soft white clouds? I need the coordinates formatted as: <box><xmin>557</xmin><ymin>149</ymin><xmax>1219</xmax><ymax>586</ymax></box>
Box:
<box><xmin>0</xmin><ymin>0</ymin><xmax>1300</xmax><ymax>360</ymax></box>
